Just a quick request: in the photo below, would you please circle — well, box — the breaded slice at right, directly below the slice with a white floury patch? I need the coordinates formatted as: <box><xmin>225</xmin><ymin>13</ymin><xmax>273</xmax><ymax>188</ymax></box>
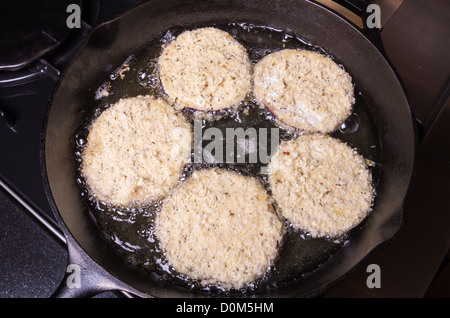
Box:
<box><xmin>268</xmin><ymin>134</ymin><xmax>374</xmax><ymax>237</ymax></box>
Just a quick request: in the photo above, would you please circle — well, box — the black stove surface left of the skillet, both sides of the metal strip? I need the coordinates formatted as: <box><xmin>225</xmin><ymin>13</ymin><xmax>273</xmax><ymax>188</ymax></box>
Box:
<box><xmin>0</xmin><ymin>0</ymin><xmax>141</xmax><ymax>298</ymax></box>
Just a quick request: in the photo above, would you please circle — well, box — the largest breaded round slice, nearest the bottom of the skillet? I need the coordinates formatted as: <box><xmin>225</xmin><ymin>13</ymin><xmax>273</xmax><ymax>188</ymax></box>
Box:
<box><xmin>155</xmin><ymin>168</ymin><xmax>284</xmax><ymax>289</ymax></box>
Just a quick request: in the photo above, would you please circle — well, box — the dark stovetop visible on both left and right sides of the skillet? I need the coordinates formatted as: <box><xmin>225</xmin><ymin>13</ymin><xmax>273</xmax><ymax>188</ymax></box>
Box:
<box><xmin>0</xmin><ymin>0</ymin><xmax>450</xmax><ymax>298</ymax></box>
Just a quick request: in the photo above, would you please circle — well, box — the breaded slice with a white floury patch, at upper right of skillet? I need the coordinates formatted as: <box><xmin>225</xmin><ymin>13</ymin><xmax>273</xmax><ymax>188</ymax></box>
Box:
<box><xmin>254</xmin><ymin>49</ymin><xmax>355</xmax><ymax>133</ymax></box>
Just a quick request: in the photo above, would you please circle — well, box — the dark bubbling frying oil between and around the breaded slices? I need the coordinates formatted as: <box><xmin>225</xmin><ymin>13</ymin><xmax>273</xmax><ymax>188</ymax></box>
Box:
<box><xmin>77</xmin><ymin>24</ymin><xmax>380</xmax><ymax>292</ymax></box>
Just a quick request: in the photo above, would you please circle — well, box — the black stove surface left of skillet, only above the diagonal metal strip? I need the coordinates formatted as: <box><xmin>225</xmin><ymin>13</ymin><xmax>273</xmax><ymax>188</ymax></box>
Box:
<box><xmin>0</xmin><ymin>0</ymin><xmax>148</xmax><ymax>224</ymax></box>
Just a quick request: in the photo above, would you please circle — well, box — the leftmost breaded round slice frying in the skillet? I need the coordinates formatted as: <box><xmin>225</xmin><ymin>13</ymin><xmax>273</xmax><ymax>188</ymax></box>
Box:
<box><xmin>81</xmin><ymin>96</ymin><xmax>193</xmax><ymax>206</ymax></box>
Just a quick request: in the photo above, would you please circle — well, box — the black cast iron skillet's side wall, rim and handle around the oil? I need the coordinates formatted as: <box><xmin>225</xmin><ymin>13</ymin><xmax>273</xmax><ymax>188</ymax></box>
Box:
<box><xmin>41</xmin><ymin>0</ymin><xmax>416</xmax><ymax>297</ymax></box>
